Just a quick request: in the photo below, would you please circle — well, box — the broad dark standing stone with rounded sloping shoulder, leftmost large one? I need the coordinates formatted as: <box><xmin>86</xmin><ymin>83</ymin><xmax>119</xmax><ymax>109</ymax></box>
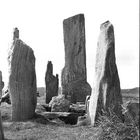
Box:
<box><xmin>8</xmin><ymin>27</ymin><xmax>37</xmax><ymax>121</ymax></box>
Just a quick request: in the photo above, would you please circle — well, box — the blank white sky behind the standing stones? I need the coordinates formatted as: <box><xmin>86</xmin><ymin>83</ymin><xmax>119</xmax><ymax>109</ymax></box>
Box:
<box><xmin>0</xmin><ymin>0</ymin><xmax>139</xmax><ymax>88</ymax></box>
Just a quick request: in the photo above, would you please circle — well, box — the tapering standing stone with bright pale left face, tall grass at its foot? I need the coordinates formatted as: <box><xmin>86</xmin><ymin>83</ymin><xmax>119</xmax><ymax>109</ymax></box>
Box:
<box><xmin>89</xmin><ymin>21</ymin><xmax>122</xmax><ymax>124</ymax></box>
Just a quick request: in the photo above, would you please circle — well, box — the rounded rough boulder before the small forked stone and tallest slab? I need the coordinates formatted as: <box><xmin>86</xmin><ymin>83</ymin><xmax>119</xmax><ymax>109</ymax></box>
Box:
<box><xmin>49</xmin><ymin>95</ymin><xmax>70</xmax><ymax>112</ymax></box>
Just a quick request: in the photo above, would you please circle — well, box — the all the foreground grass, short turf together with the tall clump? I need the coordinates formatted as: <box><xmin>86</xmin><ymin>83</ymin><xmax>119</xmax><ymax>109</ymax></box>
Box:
<box><xmin>0</xmin><ymin>88</ymin><xmax>139</xmax><ymax>140</ymax></box>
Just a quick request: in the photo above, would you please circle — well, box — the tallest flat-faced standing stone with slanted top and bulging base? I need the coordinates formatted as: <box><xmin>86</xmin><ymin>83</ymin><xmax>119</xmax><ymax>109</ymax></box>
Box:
<box><xmin>61</xmin><ymin>14</ymin><xmax>91</xmax><ymax>103</ymax></box>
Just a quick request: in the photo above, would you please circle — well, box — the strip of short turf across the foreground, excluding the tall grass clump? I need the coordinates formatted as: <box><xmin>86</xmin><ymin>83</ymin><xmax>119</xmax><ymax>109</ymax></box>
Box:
<box><xmin>3</xmin><ymin>109</ymin><xmax>100</xmax><ymax>140</ymax></box>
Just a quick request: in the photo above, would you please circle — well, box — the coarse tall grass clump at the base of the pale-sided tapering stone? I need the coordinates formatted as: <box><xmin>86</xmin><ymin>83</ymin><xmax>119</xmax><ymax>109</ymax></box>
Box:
<box><xmin>98</xmin><ymin>111</ymin><xmax>139</xmax><ymax>140</ymax></box>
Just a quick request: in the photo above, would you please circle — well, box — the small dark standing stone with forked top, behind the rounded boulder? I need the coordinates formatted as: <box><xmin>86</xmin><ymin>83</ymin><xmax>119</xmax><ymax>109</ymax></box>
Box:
<box><xmin>45</xmin><ymin>61</ymin><xmax>59</xmax><ymax>104</ymax></box>
